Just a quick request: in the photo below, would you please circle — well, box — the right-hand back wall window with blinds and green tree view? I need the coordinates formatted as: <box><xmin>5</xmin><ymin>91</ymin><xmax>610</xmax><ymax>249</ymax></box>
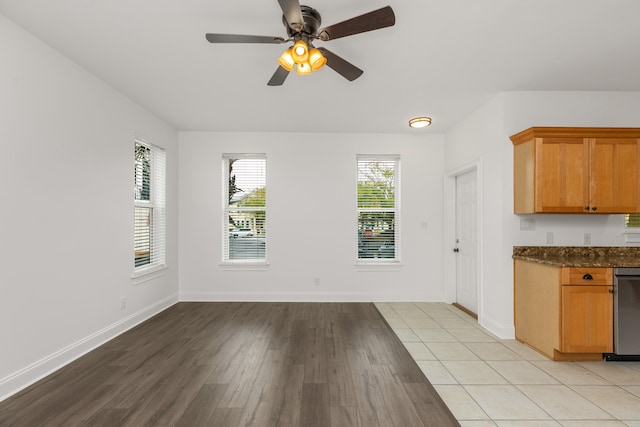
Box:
<box><xmin>357</xmin><ymin>156</ymin><xmax>400</xmax><ymax>262</ymax></box>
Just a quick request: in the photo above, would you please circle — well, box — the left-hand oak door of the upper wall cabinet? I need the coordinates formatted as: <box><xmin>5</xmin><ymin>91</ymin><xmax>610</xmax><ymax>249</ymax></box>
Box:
<box><xmin>534</xmin><ymin>138</ymin><xmax>589</xmax><ymax>213</ymax></box>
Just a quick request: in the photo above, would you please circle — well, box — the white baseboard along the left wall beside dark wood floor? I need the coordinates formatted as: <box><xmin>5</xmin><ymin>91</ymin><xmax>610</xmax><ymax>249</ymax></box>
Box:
<box><xmin>0</xmin><ymin>294</ymin><xmax>178</xmax><ymax>402</ymax></box>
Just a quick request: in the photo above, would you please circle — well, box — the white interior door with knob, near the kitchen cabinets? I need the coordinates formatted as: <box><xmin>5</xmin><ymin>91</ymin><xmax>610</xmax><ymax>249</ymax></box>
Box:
<box><xmin>454</xmin><ymin>170</ymin><xmax>478</xmax><ymax>314</ymax></box>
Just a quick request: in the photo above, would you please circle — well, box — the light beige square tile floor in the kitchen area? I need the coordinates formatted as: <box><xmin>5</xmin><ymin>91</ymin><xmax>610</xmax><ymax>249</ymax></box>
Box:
<box><xmin>376</xmin><ymin>302</ymin><xmax>640</xmax><ymax>427</ymax></box>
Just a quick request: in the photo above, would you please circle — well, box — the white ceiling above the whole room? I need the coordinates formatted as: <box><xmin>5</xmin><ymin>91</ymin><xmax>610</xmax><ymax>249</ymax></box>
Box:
<box><xmin>0</xmin><ymin>0</ymin><xmax>640</xmax><ymax>133</ymax></box>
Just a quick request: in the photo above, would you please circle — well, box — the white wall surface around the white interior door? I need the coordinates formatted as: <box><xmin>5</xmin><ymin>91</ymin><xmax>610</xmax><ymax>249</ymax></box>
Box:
<box><xmin>445</xmin><ymin>95</ymin><xmax>513</xmax><ymax>337</ymax></box>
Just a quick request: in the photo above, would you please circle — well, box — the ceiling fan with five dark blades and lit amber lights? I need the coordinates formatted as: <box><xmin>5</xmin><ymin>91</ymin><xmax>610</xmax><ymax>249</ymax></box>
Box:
<box><xmin>206</xmin><ymin>0</ymin><xmax>396</xmax><ymax>86</ymax></box>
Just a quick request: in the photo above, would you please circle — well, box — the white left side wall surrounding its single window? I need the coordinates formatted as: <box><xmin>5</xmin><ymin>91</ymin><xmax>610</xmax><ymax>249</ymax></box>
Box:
<box><xmin>0</xmin><ymin>15</ymin><xmax>178</xmax><ymax>400</ymax></box>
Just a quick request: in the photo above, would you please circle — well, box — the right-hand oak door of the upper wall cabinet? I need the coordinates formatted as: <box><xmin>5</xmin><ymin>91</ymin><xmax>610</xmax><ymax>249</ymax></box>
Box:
<box><xmin>589</xmin><ymin>138</ymin><xmax>640</xmax><ymax>213</ymax></box>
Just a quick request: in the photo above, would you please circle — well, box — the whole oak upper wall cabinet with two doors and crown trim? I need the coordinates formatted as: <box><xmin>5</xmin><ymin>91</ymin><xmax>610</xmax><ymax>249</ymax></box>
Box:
<box><xmin>511</xmin><ymin>127</ymin><xmax>640</xmax><ymax>214</ymax></box>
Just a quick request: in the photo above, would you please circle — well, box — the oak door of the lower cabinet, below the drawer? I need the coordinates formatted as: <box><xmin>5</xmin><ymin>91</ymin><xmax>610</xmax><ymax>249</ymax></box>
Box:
<box><xmin>560</xmin><ymin>285</ymin><xmax>613</xmax><ymax>353</ymax></box>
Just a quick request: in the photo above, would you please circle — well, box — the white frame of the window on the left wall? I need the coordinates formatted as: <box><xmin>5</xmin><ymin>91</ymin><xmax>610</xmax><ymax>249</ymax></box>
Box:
<box><xmin>133</xmin><ymin>138</ymin><xmax>166</xmax><ymax>278</ymax></box>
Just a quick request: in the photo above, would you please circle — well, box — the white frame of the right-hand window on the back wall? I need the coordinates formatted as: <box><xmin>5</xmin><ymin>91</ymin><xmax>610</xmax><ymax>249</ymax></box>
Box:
<box><xmin>355</xmin><ymin>154</ymin><xmax>401</xmax><ymax>267</ymax></box>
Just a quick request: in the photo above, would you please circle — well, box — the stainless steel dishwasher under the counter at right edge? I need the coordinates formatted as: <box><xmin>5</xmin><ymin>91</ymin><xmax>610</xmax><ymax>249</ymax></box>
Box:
<box><xmin>605</xmin><ymin>268</ymin><xmax>640</xmax><ymax>360</ymax></box>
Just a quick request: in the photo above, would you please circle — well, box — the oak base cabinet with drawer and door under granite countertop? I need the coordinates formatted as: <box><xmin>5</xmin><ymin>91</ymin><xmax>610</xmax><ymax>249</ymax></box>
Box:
<box><xmin>514</xmin><ymin>260</ymin><xmax>613</xmax><ymax>360</ymax></box>
